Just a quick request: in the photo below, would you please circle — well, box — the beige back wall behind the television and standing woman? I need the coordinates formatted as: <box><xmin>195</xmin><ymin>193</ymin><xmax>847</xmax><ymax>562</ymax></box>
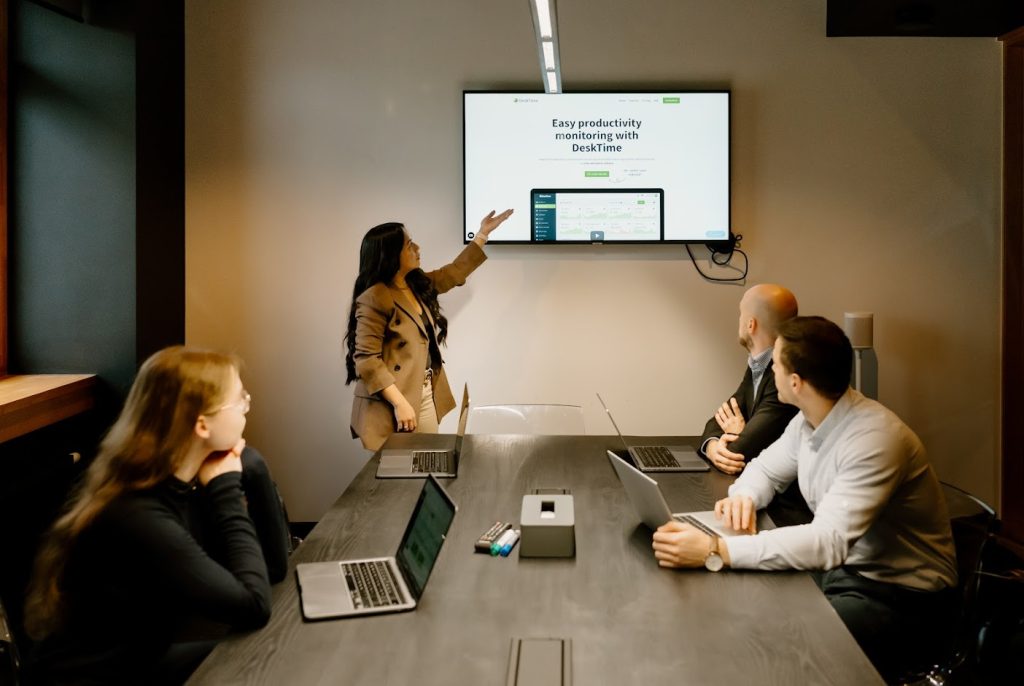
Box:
<box><xmin>186</xmin><ymin>0</ymin><xmax>1000</xmax><ymax>520</ymax></box>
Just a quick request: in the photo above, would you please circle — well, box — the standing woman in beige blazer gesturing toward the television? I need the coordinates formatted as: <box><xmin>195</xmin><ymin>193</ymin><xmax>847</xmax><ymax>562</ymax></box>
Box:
<box><xmin>345</xmin><ymin>210</ymin><xmax>512</xmax><ymax>451</ymax></box>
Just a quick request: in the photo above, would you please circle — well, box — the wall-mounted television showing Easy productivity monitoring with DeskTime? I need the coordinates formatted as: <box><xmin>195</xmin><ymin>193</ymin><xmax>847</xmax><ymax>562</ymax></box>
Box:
<box><xmin>463</xmin><ymin>90</ymin><xmax>731</xmax><ymax>245</ymax></box>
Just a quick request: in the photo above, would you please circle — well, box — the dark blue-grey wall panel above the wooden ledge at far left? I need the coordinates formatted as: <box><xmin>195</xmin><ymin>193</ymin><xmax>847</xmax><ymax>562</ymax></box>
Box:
<box><xmin>9</xmin><ymin>2</ymin><xmax>136</xmax><ymax>394</ymax></box>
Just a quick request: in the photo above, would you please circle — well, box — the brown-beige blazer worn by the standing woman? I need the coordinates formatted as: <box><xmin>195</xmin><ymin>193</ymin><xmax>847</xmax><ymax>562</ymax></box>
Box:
<box><xmin>351</xmin><ymin>243</ymin><xmax>487</xmax><ymax>451</ymax></box>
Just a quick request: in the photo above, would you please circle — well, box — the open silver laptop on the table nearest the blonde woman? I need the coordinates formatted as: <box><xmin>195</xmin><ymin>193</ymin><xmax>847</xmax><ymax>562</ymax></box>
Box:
<box><xmin>295</xmin><ymin>475</ymin><xmax>458</xmax><ymax>619</ymax></box>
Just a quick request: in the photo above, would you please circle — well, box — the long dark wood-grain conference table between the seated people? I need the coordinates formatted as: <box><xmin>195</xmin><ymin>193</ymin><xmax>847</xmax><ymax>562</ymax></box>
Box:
<box><xmin>188</xmin><ymin>434</ymin><xmax>884</xmax><ymax>686</ymax></box>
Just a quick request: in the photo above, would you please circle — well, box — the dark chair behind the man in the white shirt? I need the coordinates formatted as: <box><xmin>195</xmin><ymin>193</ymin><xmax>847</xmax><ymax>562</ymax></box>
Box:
<box><xmin>899</xmin><ymin>481</ymin><xmax>996</xmax><ymax>686</ymax></box>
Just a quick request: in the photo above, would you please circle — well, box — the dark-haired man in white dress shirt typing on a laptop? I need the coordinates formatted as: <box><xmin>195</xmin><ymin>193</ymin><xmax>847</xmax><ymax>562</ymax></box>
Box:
<box><xmin>653</xmin><ymin>316</ymin><xmax>956</xmax><ymax>677</ymax></box>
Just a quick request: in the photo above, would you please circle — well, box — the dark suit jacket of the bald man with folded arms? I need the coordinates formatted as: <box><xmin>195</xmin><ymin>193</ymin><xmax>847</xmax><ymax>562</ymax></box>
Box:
<box><xmin>700</xmin><ymin>361</ymin><xmax>797</xmax><ymax>462</ymax></box>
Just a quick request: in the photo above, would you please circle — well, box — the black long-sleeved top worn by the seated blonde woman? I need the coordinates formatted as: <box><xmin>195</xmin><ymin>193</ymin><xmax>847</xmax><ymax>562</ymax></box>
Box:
<box><xmin>35</xmin><ymin>472</ymin><xmax>270</xmax><ymax>684</ymax></box>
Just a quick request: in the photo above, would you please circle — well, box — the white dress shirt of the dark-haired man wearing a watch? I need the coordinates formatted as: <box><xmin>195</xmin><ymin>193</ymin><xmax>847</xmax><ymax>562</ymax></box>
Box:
<box><xmin>727</xmin><ymin>389</ymin><xmax>956</xmax><ymax>591</ymax></box>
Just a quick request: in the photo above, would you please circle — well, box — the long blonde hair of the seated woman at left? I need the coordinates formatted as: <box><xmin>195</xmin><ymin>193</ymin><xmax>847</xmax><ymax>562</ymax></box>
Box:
<box><xmin>25</xmin><ymin>346</ymin><xmax>239</xmax><ymax>640</ymax></box>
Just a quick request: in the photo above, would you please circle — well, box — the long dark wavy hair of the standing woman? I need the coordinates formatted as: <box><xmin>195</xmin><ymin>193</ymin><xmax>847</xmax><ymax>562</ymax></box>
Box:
<box><xmin>345</xmin><ymin>221</ymin><xmax>447</xmax><ymax>385</ymax></box>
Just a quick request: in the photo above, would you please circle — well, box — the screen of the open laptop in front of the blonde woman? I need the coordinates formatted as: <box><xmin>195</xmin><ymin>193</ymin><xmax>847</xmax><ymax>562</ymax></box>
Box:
<box><xmin>395</xmin><ymin>476</ymin><xmax>456</xmax><ymax>598</ymax></box>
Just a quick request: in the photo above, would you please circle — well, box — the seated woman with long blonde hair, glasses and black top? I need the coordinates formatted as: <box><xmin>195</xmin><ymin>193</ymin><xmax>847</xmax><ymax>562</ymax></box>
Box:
<box><xmin>25</xmin><ymin>347</ymin><xmax>270</xmax><ymax>684</ymax></box>
